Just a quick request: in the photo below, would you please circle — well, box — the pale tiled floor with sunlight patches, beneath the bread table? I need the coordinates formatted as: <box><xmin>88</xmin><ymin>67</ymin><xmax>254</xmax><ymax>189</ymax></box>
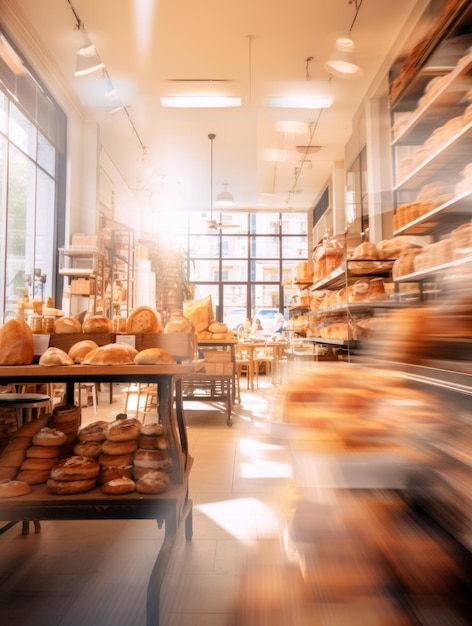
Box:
<box><xmin>0</xmin><ymin>380</ymin><xmax>291</xmax><ymax>626</ymax></box>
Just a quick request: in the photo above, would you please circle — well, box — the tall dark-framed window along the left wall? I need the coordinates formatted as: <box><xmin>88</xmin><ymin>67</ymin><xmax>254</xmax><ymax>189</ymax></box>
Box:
<box><xmin>0</xmin><ymin>33</ymin><xmax>66</xmax><ymax>321</ymax></box>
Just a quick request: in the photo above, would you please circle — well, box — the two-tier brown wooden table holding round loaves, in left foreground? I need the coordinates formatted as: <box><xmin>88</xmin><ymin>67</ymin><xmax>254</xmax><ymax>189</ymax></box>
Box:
<box><xmin>0</xmin><ymin>363</ymin><xmax>198</xmax><ymax>626</ymax></box>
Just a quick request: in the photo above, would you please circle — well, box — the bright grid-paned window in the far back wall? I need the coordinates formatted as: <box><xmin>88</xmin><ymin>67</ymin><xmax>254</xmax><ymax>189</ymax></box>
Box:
<box><xmin>181</xmin><ymin>212</ymin><xmax>308</xmax><ymax>324</ymax></box>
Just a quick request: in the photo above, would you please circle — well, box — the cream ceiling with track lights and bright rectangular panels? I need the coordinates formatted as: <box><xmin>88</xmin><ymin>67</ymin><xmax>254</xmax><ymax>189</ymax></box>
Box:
<box><xmin>8</xmin><ymin>0</ymin><xmax>425</xmax><ymax>211</ymax></box>
